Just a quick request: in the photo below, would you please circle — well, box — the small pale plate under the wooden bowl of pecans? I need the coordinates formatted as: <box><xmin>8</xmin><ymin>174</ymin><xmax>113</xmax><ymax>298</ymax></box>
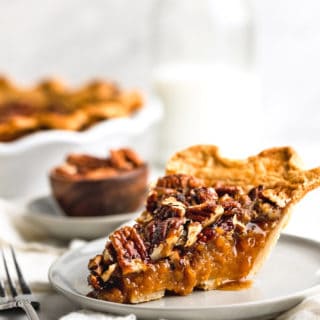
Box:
<box><xmin>25</xmin><ymin>196</ymin><xmax>136</xmax><ymax>240</ymax></box>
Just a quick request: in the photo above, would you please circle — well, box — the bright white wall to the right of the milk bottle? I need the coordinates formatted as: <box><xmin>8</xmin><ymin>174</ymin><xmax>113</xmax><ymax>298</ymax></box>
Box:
<box><xmin>255</xmin><ymin>0</ymin><xmax>320</xmax><ymax>141</ymax></box>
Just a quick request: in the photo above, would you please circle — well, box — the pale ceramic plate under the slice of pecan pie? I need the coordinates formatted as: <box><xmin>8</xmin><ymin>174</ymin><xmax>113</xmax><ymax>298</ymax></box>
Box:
<box><xmin>49</xmin><ymin>235</ymin><xmax>320</xmax><ymax>320</ymax></box>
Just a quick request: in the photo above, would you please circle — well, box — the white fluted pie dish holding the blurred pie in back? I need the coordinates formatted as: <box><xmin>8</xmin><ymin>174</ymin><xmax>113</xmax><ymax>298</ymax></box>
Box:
<box><xmin>0</xmin><ymin>98</ymin><xmax>162</xmax><ymax>198</ymax></box>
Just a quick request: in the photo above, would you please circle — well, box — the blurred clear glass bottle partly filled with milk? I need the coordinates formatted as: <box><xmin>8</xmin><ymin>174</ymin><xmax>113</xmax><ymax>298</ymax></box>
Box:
<box><xmin>153</xmin><ymin>0</ymin><xmax>260</xmax><ymax>163</ymax></box>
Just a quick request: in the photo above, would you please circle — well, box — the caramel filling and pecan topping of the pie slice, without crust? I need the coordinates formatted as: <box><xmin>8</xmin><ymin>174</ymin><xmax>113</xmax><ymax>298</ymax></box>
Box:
<box><xmin>88</xmin><ymin>174</ymin><xmax>282</xmax><ymax>303</ymax></box>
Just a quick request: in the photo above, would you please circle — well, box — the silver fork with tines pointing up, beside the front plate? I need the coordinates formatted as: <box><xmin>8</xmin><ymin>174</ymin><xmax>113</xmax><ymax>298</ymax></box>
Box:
<box><xmin>0</xmin><ymin>246</ymin><xmax>40</xmax><ymax>320</ymax></box>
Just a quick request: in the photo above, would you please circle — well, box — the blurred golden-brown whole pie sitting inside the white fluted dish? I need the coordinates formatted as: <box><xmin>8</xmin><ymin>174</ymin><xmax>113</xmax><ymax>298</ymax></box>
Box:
<box><xmin>0</xmin><ymin>77</ymin><xmax>143</xmax><ymax>142</ymax></box>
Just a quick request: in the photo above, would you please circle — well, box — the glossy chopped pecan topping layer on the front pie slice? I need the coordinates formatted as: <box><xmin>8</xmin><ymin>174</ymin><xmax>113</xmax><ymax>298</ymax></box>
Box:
<box><xmin>89</xmin><ymin>175</ymin><xmax>285</xmax><ymax>298</ymax></box>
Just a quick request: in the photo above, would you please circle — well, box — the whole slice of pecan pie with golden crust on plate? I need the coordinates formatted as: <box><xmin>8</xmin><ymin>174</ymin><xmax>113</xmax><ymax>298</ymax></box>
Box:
<box><xmin>88</xmin><ymin>146</ymin><xmax>320</xmax><ymax>303</ymax></box>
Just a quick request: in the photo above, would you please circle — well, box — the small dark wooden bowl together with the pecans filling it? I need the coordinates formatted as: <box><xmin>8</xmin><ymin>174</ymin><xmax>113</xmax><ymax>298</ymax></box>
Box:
<box><xmin>50</xmin><ymin>149</ymin><xmax>148</xmax><ymax>216</ymax></box>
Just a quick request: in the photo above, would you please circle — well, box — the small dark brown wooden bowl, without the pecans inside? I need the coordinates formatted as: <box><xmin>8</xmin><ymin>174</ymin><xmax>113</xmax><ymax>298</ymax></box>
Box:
<box><xmin>50</xmin><ymin>164</ymin><xmax>148</xmax><ymax>217</ymax></box>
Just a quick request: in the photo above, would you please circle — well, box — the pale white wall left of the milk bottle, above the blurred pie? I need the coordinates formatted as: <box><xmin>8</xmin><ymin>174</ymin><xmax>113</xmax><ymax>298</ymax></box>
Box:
<box><xmin>0</xmin><ymin>0</ymin><xmax>155</xmax><ymax>85</ymax></box>
